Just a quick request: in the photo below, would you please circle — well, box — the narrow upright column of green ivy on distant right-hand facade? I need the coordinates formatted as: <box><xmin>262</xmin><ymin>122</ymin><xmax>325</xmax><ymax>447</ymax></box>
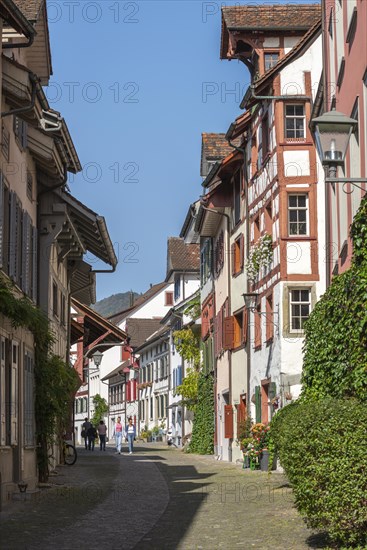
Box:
<box><xmin>188</xmin><ymin>372</ymin><xmax>214</xmax><ymax>454</ymax></box>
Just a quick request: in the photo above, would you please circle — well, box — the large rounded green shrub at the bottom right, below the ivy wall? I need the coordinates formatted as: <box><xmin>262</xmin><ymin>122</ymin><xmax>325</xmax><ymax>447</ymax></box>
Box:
<box><xmin>271</xmin><ymin>399</ymin><xmax>367</xmax><ymax>548</ymax></box>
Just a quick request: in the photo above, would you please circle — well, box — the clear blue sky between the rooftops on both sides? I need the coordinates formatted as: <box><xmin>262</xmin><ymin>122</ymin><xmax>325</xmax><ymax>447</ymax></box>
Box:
<box><xmin>47</xmin><ymin>0</ymin><xmax>320</xmax><ymax>299</ymax></box>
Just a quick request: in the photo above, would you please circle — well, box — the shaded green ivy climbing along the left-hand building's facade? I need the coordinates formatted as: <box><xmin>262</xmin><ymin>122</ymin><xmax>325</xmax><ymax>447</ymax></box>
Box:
<box><xmin>0</xmin><ymin>277</ymin><xmax>78</xmax><ymax>481</ymax></box>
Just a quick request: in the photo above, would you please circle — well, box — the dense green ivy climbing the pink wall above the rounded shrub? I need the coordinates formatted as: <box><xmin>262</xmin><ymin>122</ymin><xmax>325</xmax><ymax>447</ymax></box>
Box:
<box><xmin>302</xmin><ymin>194</ymin><xmax>367</xmax><ymax>401</ymax></box>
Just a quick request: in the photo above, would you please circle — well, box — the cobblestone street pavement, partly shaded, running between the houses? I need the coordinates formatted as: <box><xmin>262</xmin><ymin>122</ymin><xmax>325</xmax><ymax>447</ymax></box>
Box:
<box><xmin>0</xmin><ymin>444</ymin><xmax>324</xmax><ymax>550</ymax></box>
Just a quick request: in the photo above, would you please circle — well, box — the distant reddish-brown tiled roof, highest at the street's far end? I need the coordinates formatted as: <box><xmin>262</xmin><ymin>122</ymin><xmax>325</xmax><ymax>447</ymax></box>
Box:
<box><xmin>166</xmin><ymin>237</ymin><xmax>200</xmax><ymax>281</ymax></box>
